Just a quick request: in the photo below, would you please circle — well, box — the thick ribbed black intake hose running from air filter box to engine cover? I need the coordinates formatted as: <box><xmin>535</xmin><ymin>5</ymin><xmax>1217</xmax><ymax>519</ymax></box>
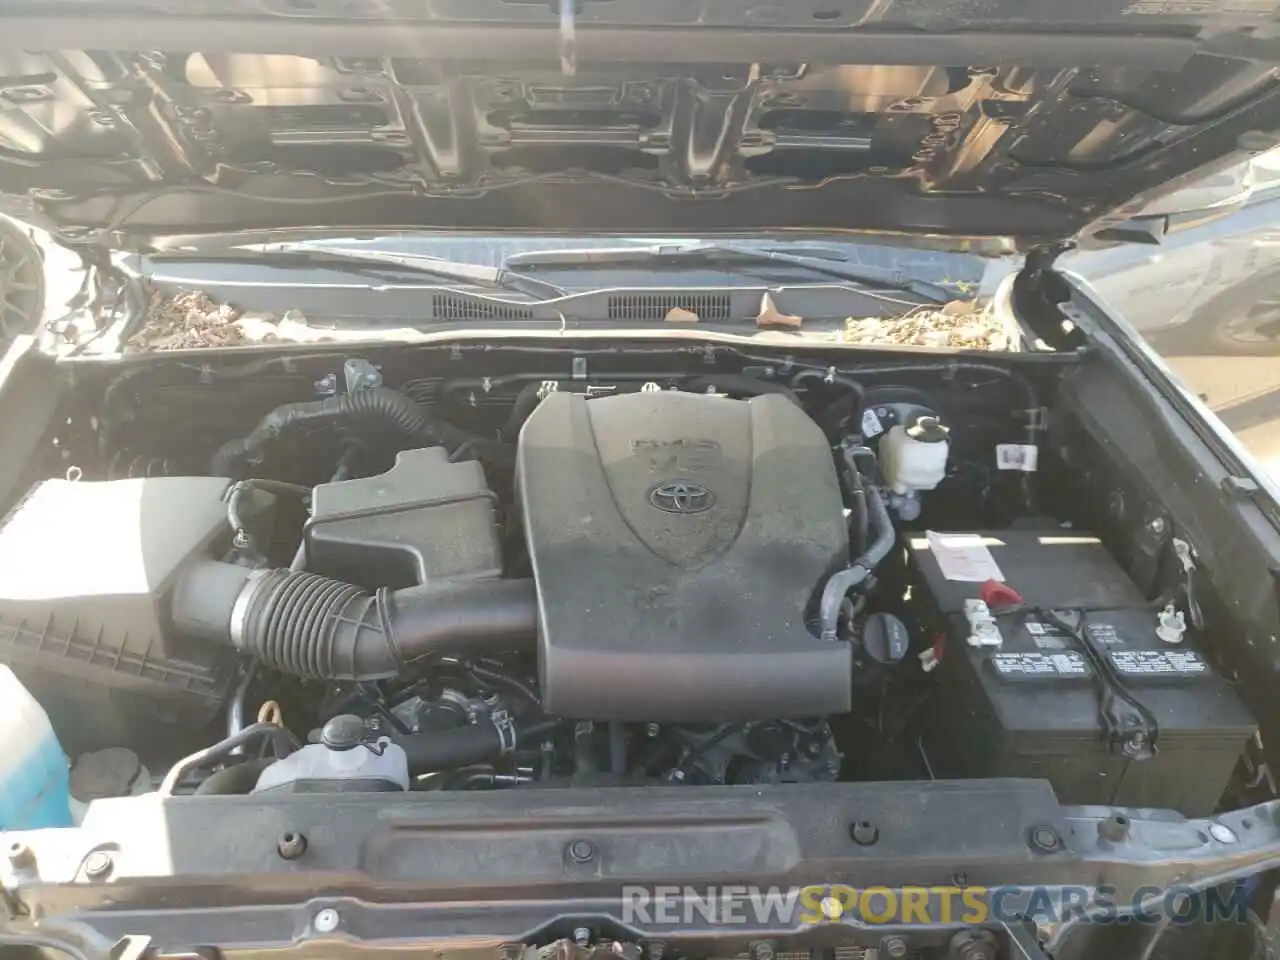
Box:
<box><xmin>172</xmin><ymin>561</ymin><xmax>538</xmax><ymax>681</ymax></box>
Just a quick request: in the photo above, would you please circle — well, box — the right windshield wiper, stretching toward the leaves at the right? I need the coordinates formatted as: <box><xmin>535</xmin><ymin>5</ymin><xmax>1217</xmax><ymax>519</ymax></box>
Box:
<box><xmin>503</xmin><ymin>243</ymin><xmax>955</xmax><ymax>303</ymax></box>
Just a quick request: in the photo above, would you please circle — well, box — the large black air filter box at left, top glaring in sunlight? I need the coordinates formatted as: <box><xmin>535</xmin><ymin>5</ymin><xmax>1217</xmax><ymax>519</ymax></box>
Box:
<box><xmin>0</xmin><ymin>477</ymin><xmax>230</xmax><ymax>754</ymax></box>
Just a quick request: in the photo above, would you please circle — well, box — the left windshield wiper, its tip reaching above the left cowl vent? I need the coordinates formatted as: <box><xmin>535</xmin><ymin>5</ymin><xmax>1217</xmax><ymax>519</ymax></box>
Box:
<box><xmin>150</xmin><ymin>243</ymin><xmax>566</xmax><ymax>300</ymax></box>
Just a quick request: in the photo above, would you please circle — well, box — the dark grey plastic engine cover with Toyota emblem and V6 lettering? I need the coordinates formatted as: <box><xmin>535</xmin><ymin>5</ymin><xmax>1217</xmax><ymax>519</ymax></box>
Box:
<box><xmin>517</xmin><ymin>392</ymin><xmax>852</xmax><ymax>722</ymax></box>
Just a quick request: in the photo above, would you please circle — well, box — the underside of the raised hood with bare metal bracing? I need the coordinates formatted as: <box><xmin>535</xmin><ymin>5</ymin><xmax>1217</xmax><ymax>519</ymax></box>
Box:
<box><xmin>0</xmin><ymin>0</ymin><xmax>1280</xmax><ymax>247</ymax></box>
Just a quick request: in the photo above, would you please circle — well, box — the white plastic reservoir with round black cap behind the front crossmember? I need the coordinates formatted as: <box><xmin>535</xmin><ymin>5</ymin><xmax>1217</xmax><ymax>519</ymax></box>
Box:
<box><xmin>253</xmin><ymin>714</ymin><xmax>408</xmax><ymax>794</ymax></box>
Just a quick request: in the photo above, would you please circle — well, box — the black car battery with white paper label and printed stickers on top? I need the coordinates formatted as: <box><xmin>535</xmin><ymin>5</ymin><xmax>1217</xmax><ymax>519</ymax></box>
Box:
<box><xmin>910</xmin><ymin>530</ymin><xmax>1256</xmax><ymax>817</ymax></box>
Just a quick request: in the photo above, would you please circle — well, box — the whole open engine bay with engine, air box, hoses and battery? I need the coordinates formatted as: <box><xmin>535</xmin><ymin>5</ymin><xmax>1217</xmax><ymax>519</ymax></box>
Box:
<box><xmin>0</xmin><ymin>347</ymin><xmax>1257</xmax><ymax>815</ymax></box>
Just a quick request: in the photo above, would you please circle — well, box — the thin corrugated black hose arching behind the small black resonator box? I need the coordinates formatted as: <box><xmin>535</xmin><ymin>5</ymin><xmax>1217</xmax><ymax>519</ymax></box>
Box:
<box><xmin>212</xmin><ymin>387</ymin><xmax>440</xmax><ymax>476</ymax></box>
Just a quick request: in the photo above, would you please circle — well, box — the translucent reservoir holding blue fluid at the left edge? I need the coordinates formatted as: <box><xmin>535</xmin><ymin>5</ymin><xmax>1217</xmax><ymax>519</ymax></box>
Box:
<box><xmin>0</xmin><ymin>666</ymin><xmax>72</xmax><ymax>829</ymax></box>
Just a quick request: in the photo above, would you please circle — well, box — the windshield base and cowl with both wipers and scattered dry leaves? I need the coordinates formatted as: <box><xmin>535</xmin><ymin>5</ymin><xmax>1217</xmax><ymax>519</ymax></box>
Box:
<box><xmin>92</xmin><ymin>233</ymin><xmax>1010</xmax><ymax>351</ymax></box>
